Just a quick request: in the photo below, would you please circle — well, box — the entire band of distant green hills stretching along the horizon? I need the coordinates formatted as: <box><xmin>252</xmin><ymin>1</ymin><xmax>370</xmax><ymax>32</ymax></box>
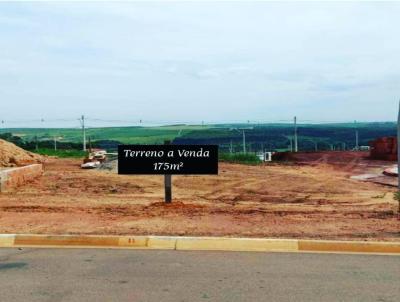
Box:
<box><xmin>0</xmin><ymin>122</ymin><xmax>396</xmax><ymax>151</ymax></box>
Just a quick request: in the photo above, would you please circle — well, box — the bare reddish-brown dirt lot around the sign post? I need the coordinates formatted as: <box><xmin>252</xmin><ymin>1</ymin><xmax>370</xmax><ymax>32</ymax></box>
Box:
<box><xmin>0</xmin><ymin>153</ymin><xmax>400</xmax><ymax>240</ymax></box>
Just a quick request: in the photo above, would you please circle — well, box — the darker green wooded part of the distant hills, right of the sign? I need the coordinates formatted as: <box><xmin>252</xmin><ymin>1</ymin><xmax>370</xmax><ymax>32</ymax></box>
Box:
<box><xmin>174</xmin><ymin>122</ymin><xmax>396</xmax><ymax>151</ymax></box>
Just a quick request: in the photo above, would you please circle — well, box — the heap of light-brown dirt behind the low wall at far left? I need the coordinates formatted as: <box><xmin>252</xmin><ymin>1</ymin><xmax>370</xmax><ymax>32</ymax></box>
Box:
<box><xmin>0</xmin><ymin>139</ymin><xmax>44</xmax><ymax>167</ymax></box>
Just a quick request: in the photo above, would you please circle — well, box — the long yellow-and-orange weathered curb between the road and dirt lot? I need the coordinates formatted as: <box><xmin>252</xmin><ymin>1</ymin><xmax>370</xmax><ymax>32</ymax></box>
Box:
<box><xmin>0</xmin><ymin>234</ymin><xmax>400</xmax><ymax>255</ymax></box>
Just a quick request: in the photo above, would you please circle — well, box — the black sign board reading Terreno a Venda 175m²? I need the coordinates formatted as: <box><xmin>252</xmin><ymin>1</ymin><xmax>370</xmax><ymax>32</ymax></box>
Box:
<box><xmin>118</xmin><ymin>145</ymin><xmax>218</xmax><ymax>175</ymax></box>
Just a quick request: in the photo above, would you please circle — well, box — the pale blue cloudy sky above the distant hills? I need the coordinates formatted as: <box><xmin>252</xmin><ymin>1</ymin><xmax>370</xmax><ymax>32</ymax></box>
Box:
<box><xmin>0</xmin><ymin>2</ymin><xmax>400</xmax><ymax>126</ymax></box>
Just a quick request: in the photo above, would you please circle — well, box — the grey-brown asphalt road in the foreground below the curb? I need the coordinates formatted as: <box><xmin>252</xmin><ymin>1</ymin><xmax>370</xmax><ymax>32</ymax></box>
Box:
<box><xmin>0</xmin><ymin>248</ymin><xmax>400</xmax><ymax>302</ymax></box>
